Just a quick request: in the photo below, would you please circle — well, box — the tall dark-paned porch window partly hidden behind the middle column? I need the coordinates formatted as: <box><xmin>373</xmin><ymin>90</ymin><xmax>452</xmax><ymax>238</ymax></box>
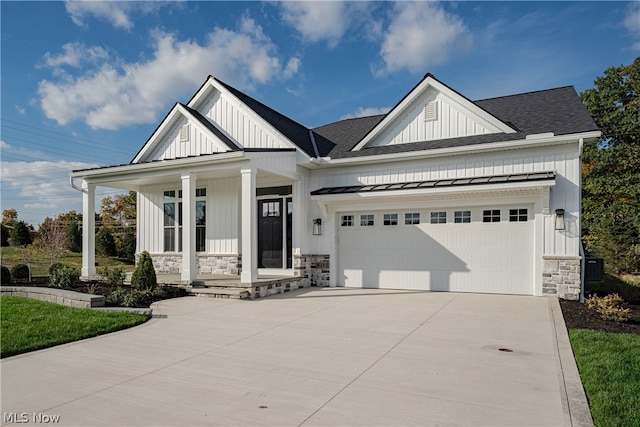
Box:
<box><xmin>163</xmin><ymin>188</ymin><xmax>207</xmax><ymax>252</ymax></box>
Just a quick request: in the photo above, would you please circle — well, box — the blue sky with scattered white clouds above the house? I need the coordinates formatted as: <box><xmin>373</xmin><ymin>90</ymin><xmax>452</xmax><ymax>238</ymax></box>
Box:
<box><xmin>0</xmin><ymin>1</ymin><xmax>640</xmax><ymax>226</ymax></box>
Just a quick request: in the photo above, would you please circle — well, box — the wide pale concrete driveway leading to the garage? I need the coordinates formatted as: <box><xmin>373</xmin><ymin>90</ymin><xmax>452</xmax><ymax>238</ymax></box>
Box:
<box><xmin>1</xmin><ymin>288</ymin><xmax>590</xmax><ymax>426</ymax></box>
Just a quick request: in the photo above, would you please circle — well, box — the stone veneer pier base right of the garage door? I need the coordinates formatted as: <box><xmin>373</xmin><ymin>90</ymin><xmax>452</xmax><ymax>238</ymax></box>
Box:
<box><xmin>542</xmin><ymin>255</ymin><xmax>581</xmax><ymax>300</ymax></box>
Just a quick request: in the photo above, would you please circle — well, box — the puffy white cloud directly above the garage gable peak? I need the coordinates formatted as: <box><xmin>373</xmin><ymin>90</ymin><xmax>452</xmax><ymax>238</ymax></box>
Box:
<box><xmin>376</xmin><ymin>2</ymin><xmax>472</xmax><ymax>75</ymax></box>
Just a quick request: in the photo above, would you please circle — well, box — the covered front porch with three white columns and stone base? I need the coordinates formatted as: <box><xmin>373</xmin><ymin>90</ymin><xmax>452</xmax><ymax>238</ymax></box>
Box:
<box><xmin>71</xmin><ymin>149</ymin><xmax>311</xmax><ymax>288</ymax></box>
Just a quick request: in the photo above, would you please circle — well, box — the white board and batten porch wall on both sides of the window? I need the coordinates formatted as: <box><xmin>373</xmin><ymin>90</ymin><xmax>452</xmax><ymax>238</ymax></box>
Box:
<box><xmin>138</xmin><ymin>177</ymin><xmax>240</xmax><ymax>254</ymax></box>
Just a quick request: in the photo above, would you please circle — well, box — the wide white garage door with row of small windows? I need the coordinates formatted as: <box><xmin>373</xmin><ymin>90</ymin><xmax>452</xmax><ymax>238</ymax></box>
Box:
<box><xmin>337</xmin><ymin>206</ymin><xmax>534</xmax><ymax>295</ymax></box>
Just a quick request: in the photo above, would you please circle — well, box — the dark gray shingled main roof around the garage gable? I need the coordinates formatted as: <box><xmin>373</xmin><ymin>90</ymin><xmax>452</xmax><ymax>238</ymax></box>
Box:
<box><xmin>216</xmin><ymin>74</ymin><xmax>598</xmax><ymax>158</ymax></box>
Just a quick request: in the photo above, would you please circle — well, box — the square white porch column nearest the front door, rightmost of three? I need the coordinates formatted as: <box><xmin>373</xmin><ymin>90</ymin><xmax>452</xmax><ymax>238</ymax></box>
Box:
<box><xmin>240</xmin><ymin>167</ymin><xmax>258</xmax><ymax>283</ymax></box>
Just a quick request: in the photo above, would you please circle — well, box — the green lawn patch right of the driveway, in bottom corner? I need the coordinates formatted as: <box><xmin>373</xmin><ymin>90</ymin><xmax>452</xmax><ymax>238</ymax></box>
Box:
<box><xmin>569</xmin><ymin>329</ymin><xmax>640</xmax><ymax>427</ymax></box>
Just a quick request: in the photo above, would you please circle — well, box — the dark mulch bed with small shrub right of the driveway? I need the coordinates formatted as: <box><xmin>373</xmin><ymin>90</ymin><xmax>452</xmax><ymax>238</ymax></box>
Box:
<box><xmin>560</xmin><ymin>299</ymin><xmax>640</xmax><ymax>335</ymax></box>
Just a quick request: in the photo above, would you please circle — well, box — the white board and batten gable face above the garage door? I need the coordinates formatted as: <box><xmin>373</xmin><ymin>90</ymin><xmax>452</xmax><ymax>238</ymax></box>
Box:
<box><xmin>368</xmin><ymin>88</ymin><xmax>493</xmax><ymax>146</ymax></box>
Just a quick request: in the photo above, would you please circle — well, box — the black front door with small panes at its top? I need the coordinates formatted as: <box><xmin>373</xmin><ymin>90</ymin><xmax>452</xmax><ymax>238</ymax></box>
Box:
<box><xmin>258</xmin><ymin>199</ymin><xmax>284</xmax><ymax>268</ymax></box>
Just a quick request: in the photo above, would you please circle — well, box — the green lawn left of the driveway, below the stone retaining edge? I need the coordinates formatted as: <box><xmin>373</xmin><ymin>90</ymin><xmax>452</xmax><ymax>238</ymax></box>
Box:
<box><xmin>0</xmin><ymin>296</ymin><xmax>147</xmax><ymax>357</ymax></box>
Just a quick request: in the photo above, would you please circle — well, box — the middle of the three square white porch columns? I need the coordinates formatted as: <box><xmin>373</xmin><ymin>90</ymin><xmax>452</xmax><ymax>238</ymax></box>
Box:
<box><xmin>181</xmin><ymin>173</ymin><xmax>198</xmax><ymax>282</ymax></box>
